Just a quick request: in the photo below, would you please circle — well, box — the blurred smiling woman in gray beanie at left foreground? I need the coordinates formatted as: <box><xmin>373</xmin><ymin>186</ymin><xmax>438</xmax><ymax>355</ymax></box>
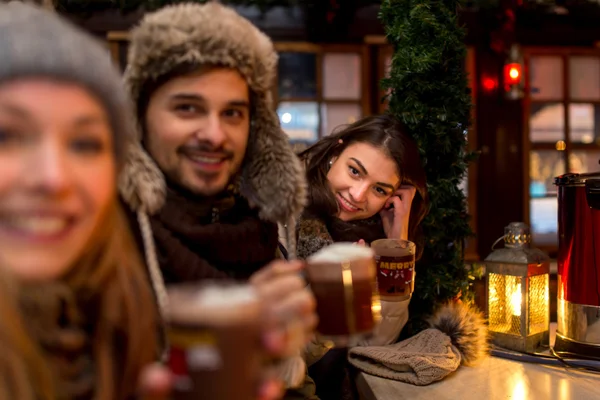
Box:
<box><xmin>0</xmin><ymin>2</ymin><xmax>157</xmax><ymax>400</ymax></box>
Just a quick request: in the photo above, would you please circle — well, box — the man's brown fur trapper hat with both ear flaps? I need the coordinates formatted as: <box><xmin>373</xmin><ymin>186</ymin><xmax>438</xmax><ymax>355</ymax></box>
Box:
<box><xmin>121</xmin><ymin>2</ymin><xmax>306</xmax><ymax>231</ymax></box>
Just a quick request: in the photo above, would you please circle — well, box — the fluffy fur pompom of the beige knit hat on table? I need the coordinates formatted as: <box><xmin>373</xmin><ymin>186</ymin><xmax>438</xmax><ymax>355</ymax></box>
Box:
<box><xmin>429</xmin><ymin>302</ymin><xmax>489</xmax><ymax>365</ymax></box>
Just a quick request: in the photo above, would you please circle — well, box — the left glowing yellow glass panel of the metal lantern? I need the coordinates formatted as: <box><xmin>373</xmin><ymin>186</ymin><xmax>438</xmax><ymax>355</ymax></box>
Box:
<box><xmin>488</xmin><ymin>273</ymin><xmax>522</xmax><ymax>336</ymax></box>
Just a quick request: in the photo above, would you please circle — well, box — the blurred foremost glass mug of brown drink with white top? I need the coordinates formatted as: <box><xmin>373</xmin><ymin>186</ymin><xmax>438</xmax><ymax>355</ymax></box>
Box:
<box><xmin>167</xmin><ymin>282</ymin><xmax>266</xmax><ymax>400</ymax></box>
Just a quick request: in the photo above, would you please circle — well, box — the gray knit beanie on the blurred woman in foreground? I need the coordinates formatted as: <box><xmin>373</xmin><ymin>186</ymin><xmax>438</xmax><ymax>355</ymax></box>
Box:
<box><xmin>0</xmin><ymin>1</ymin><xmax>134</xmax><ymax>166</ymax></box>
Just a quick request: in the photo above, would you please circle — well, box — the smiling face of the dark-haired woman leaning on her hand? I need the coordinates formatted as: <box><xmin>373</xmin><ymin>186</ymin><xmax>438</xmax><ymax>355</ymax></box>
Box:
<box><xmin>327</xmin><ymin>143</ymin><xmax>400</xmax><ymax>221</ymax></box>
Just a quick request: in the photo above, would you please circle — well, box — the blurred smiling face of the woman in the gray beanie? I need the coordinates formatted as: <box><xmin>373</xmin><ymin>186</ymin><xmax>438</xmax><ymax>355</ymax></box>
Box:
<box><xmin>0</xmin><ymin>79</ymin><xmax>116</xmax><ymax>280</ymax></box>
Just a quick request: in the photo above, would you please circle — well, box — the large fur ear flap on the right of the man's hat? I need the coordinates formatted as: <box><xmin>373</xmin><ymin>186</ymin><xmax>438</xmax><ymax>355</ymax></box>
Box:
<box><xmin>240</xmin><ymin>92</ymin><xmax>307</xmax><ymax>224</ymax></box>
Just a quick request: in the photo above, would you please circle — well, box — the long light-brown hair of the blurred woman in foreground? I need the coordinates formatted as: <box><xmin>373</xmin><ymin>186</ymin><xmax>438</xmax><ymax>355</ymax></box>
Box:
<box><xmin>0</xmin><ymin>199</ymin><xmax>158</xmax><ymax>400</ymax></box>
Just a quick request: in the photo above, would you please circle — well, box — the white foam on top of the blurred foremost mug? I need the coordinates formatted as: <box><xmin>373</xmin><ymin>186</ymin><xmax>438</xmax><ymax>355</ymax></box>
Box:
<box><xmin>168</xmin><ymin>284</ymin><xmax>260</xmax><ymax>325</ymax></box>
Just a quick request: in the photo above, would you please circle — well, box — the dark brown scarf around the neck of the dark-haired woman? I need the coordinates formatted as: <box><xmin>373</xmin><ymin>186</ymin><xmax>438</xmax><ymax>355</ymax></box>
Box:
<box><xmin>296</xmin><ymin>212</ymin><xmax>385</xmax><ymax>259</ymax></box>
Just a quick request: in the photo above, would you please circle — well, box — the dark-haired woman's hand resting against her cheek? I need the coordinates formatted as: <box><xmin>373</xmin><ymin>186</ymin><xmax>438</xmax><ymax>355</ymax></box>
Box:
<box><xmin>379</xmin><ymin>185</ymin><xmax>417</xmax><ymax>240</ymax></box>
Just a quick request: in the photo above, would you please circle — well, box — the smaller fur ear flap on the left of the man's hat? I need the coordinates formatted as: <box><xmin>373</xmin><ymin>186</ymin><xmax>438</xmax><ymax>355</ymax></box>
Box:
<box><xmin>119</xmin><ymin>143</ymin><xmax>167</xmax><ymax>214</ymax></box>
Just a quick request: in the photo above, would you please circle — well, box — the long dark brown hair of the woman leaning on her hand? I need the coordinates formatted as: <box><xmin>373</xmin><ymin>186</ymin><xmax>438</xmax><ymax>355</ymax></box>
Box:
<box><xmin>299</xmin><ymin>114</ymin><xmax>428</xmax><ymax>255</ymax></box>
